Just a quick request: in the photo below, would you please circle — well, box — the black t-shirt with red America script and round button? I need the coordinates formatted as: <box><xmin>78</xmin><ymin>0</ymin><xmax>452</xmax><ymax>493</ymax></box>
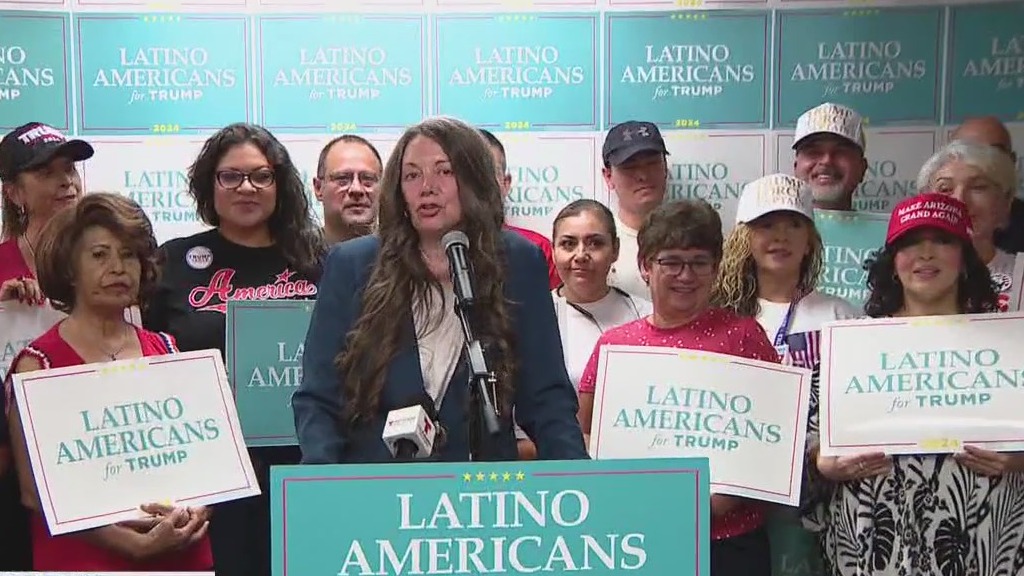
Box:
<box><xmin>142</xmin><ymin>230</ymin><xmax>318</xmax><ymax>356</ymax></box>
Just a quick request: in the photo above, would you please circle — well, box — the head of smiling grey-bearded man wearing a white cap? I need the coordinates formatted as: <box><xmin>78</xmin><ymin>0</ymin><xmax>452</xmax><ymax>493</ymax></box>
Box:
<box><xmin>793</xmin><ymin>102</ymin><xmax>867</xmax><ymax>211</ymax></box>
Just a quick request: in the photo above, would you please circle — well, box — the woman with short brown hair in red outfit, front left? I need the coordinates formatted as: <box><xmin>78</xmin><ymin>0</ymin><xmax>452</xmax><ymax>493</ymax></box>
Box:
<box><xmin>5</xmin><ymin>194</ymin><xmax>213</xmax><ymax>572</ymax></box>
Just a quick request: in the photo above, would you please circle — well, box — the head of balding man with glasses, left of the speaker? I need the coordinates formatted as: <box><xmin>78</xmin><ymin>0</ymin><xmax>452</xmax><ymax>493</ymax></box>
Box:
<box><xmin>313</xmin><ymin>134</ymin><xmax>384</xmax><ymax>246</ymax></box>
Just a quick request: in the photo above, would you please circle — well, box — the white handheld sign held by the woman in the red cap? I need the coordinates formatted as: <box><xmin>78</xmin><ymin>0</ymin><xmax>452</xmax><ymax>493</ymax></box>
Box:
<box><xmin>819</xmin><ymin>312</ymin><xmax>1024</xmax><ymax>456</ymax></box>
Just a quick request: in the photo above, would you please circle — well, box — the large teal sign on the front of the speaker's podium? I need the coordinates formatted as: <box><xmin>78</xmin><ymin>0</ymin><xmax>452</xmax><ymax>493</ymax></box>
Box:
<box><xmin>270</xmin><ymin>458</ymin><xmax>711</xmax><ymax>576</ymax></box>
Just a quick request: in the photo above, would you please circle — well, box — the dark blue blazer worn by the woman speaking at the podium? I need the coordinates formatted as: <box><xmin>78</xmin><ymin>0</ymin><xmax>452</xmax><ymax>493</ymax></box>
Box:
<box><xmin>292</xmin><ymin>231</ymin><xmax>589</xmax><ymax>464</ymax></box>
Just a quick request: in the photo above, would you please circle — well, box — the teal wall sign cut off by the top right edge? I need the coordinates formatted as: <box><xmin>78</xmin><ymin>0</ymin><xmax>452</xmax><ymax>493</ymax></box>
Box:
<box><xmin>946</xmin><ymin>2</ymin><xmax>1024</xmax><ymax>123</ymax></box>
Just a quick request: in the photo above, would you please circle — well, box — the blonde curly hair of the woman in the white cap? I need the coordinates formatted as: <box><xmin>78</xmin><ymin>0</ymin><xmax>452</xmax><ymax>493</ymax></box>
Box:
<box><xmin>711</xmin><ymin>223</ymin><xmax>824</xmax><ymax>318</ymax></box>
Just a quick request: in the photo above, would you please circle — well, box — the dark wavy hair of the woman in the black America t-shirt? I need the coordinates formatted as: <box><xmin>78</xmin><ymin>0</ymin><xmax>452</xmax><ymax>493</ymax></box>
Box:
<box><xmin>188</xmin><ymin>123</ymin><xmax>327</xmax><ymax>279</ymax></box>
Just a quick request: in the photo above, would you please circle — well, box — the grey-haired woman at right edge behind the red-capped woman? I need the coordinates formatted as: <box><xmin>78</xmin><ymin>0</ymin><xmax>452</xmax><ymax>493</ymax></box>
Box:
<box><xmin>918</xmin><ymin>140</ymin><xmax>1017</xmax><ymax>312</ymax></box>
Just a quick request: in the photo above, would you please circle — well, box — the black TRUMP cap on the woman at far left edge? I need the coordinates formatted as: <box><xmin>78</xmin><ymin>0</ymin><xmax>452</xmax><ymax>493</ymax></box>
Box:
<box><xmin>0</xmin><ymin>122</ymin><xmax>93</xmax><ymax>180</ymax></box>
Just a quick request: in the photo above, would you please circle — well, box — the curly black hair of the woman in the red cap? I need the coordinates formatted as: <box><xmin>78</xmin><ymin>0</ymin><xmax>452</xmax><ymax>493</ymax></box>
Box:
<box><xmin>864</xmin><ymin>232</ymin><xmax>998</xmax><ymax>318</ymax></box>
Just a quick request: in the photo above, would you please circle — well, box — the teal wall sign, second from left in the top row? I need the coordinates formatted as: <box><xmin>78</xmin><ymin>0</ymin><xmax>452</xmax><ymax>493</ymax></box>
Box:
<box><xmin>75</xmin><ymin>13</ymin><xmax>252</xmax><ymax>135</ymax></box>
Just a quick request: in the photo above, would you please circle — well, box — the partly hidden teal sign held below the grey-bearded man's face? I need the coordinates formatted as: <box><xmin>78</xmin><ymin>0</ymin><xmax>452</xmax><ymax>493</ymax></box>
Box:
<box><xmin>814</xmin><ymin>210</ymin><xmax>889</xmax><ymax>308</ymax></box>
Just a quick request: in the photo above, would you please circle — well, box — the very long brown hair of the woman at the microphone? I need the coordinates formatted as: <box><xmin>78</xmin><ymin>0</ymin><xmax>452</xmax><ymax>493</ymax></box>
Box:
<box><xmin>335</xmin><ymin>117</ymin><xmax>515</xmax><ymax>425</ymax></box>
